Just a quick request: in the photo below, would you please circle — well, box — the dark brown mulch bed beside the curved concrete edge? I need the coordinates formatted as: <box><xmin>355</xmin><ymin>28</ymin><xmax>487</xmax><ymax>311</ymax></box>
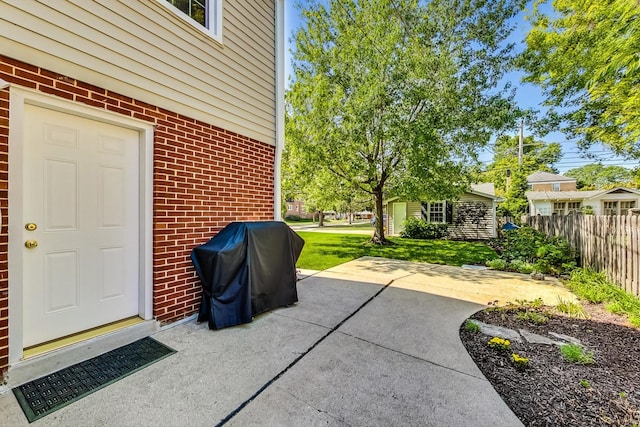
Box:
<box><xmin>460</xmin><ymin>308</ymin><xmax>640</xmax><ymax>426</ymax></box>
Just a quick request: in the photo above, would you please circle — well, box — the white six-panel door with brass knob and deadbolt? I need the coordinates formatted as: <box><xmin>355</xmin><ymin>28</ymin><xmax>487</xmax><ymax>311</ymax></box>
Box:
<box><xmin>21</xmin><ymin>105</ymin><xmax>140</xmax><ymax>347</ymax></box>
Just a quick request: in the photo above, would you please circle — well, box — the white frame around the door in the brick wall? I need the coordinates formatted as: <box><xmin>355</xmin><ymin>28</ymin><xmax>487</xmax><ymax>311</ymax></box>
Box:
<box><xmin>7</xmin><ymin>85</ymin><xmax>154</xmax><ymax>364</ymax></box>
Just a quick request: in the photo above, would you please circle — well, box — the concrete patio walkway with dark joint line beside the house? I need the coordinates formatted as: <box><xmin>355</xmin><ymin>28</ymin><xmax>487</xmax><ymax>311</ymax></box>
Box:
<box><xmin>0</xmin><ymin>258</ymin><xmax>573</xmax><ymax>426</ymax></box>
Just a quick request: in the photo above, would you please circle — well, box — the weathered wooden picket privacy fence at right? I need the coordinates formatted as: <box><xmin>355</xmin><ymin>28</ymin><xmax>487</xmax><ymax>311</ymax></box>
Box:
<box><xmin>527</xmin><ymin>215</ymin><xmax>640</xmax><ymax>296</ymax></box>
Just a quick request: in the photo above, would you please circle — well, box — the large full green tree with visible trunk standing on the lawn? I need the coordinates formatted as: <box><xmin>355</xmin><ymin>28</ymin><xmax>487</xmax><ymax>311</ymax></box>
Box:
<box><xmin>287</xmin><ymin>0</ymin><xmax>522</xmax><ymax>243</ymax></box>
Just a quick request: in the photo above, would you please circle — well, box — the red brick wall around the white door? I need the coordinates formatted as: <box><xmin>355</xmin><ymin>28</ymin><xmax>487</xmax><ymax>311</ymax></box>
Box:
<box><xmin>0</xmin><ymin>55</ymin><xmax>275</xmax><ymax>373</ymax></box>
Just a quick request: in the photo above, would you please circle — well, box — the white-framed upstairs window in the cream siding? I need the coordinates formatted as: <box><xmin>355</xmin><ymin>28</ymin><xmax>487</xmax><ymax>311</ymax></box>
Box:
<box><xmin>159</xmin><ymin>0</ymin><xmax>222</xmax><ymax>41</ymax></box>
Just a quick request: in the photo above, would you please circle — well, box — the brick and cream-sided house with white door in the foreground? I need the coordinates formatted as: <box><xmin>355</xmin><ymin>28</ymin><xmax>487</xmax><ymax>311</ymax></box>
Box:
<box><xmin>0</xmin><ymin>0</ymin><xmax>284</xmax><ymax>384</ymax></box>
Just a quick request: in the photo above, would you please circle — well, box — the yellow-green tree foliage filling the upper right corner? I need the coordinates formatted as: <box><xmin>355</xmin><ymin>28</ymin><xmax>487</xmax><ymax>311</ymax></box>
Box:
<box><xmin>522</xmin><ymin>0</ymin><xmax>640</xmax><ymax>158</ymax></box>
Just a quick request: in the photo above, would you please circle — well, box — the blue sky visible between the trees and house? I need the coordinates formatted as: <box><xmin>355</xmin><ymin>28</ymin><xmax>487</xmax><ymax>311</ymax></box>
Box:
<box><xmin>285</xmin><ymin>0</ymin><xmax>635</xmax><ymax>173</ymax></box>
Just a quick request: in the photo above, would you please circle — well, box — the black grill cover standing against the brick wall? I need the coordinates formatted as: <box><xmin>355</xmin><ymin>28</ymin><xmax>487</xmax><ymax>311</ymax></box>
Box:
<box><xmin>191</xmin><ymin>221</ymin><xmax>304</xmax><ymax>329</ymax></box>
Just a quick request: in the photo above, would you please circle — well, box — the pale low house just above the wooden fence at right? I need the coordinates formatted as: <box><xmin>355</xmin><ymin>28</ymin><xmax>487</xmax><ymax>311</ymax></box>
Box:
<box><xmin>526</xmin><ymin>187</ymin><xmax>640</xmax><ymax>216</ymax></box>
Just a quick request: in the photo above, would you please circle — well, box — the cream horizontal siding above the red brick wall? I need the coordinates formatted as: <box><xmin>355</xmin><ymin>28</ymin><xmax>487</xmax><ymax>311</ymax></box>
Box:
<box><xmin>0</xmin><ymin>0</ymin><xmax>275</xmax><ymax>144</ymax></box>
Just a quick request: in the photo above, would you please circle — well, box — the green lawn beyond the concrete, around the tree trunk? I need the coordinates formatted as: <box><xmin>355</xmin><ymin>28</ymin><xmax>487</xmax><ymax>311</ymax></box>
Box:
<box><xmin>298</xmin><ymin>232</ymin><xmax>497</xmax><ymax>270</ymax></box>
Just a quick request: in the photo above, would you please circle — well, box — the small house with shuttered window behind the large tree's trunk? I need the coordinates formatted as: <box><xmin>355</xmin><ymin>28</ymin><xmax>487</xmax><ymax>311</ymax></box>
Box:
<box><xmin>383</xmin><ymin>183</ymin><xmax>500</xmax><ymax>239</ymax></box>
